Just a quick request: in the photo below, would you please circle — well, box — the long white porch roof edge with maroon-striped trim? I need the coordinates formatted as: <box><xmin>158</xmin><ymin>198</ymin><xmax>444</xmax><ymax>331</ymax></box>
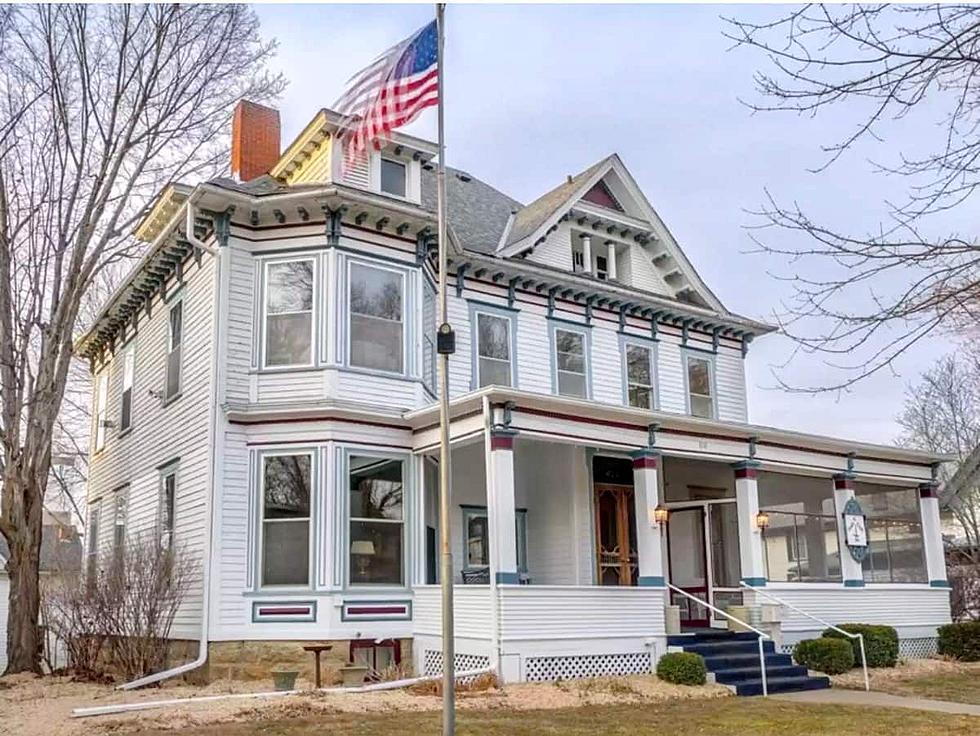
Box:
<box><xmin>405</xmin><ymin>386</ymin><xmax>949</xmax><ymax>476</ymax></box>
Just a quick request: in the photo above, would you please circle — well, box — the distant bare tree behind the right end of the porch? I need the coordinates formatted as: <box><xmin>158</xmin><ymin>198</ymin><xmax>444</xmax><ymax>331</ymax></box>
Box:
<box><xmin>897</xmin><ymin>344</ymin><xmax>980</xmax><ymax>562</ymax></box>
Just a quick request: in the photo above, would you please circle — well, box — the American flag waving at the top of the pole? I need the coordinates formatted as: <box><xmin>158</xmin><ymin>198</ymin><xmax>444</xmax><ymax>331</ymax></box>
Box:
<box><xmin>334</xmin><ymin>21</ymin><xmax>439</xmax><ymax>165</ymax></box>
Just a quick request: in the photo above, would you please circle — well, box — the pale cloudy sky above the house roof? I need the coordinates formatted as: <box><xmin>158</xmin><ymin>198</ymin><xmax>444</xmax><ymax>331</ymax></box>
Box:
<box><xmin>256</xmin><ymin>5</ymin><xmax>966</xmax><ymax>444</ymax></box>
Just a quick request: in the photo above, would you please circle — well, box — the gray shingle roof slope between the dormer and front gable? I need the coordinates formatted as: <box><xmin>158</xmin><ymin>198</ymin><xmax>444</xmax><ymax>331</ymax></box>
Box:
<box><xmin>422</xmin><ymin>167</ymin><xmax>523</xmax><ymax>254</ymax></box>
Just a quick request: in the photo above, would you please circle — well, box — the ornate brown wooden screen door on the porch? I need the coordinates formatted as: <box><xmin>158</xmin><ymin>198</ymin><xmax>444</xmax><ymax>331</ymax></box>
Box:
<box><xmin>593</xmin><ymin>483</ymin><xmax>638</xmax><ymax>585</ymax></box>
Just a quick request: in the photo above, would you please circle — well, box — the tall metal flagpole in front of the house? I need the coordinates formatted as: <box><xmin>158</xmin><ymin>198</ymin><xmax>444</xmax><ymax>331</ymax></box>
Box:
<box><xmin>436</xmin><ymin>3</ymin><xmax>456</xmax><ymax>736</ymax></box>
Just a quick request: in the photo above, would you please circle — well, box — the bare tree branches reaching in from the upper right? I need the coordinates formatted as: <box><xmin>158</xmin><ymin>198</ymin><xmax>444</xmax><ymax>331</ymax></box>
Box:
<box><xmin>727</xmin><ymin>4</ymin><xmax>980</xmax><ymax>391</ymax></box>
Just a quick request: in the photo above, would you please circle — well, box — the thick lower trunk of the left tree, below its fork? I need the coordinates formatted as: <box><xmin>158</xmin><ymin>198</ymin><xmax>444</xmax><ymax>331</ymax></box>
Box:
<box><xmin>4</xmin><ymin>486</ymin><xmax>41</xmax><ymax>675</ymax></box>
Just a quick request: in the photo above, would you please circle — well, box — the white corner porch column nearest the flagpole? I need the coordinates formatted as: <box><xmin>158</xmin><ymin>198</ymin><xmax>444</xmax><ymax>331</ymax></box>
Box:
<box><xmin>487</xmin><ymin>427</ymin><xmax>520</xmax><ymax>584</ymax></box>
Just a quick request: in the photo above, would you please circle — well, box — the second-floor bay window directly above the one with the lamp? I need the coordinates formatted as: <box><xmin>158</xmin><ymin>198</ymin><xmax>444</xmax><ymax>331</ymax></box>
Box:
<box><xmin>349</xmin><ymin>263</ymin><xmax>405</xmax><ymax>373</ymax></box>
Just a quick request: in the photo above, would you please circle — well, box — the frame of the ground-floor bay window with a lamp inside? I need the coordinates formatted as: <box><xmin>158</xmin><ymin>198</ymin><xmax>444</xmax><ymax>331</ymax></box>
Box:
<box><xmin>338</xmin><ymin>446</ymin><xmax>414</xmax><ymax>592</ymax></box>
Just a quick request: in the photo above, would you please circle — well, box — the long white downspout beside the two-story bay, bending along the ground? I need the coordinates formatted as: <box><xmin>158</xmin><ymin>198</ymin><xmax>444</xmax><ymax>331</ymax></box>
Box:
<box><xmin>116</xmin><ymin>196</ymin><xmax>226</xmax><ymax>690</ymax></box>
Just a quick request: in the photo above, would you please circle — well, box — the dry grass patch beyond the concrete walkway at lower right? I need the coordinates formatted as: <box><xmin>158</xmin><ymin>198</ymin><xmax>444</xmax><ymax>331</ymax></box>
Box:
<box><xmin>833</xmin><ymin>659</ymin><xmax>980</xmax><ymax>705</ymax></box>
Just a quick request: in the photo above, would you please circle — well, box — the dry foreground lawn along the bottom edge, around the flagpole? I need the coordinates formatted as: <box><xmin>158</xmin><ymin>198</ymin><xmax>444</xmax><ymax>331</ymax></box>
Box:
<box><xmin>132</xmin><ymin>698</ymin><xmax>980</xmax><ymax>736</ymax></box>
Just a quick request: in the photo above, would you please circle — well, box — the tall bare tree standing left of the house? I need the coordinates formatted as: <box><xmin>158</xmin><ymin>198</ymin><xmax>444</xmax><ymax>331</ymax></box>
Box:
<box><xmin>0</xmin><ymin>4</ymin><xmax>282</xmax><ymax>673</ymax></box>
